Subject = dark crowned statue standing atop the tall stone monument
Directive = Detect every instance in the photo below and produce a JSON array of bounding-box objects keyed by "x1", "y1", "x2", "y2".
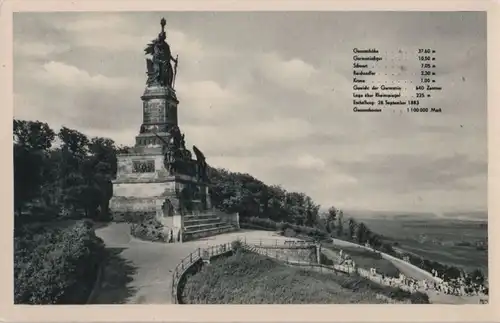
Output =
[{"x1": 144, "y1": 18, "x2": 178, "y2": 88}]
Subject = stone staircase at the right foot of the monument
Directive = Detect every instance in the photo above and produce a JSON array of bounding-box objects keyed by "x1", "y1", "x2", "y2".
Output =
[{"x1": 183, "y1": 212, "x2": 237, "y2": 241}]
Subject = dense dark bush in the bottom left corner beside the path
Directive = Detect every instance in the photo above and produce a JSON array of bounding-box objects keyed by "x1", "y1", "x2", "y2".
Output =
[{"x1": 14, "y1": 221, "x2": 104, "y2": 304}]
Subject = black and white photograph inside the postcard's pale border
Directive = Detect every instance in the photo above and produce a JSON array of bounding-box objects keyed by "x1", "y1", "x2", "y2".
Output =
[{"x1": 10, "y1": 8, "x2": 489, "y2": 308}]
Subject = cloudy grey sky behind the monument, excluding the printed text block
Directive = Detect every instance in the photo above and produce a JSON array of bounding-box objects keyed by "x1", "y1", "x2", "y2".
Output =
[{"x1": 14, "y1": 12, "x2": 487, "y2": 213}]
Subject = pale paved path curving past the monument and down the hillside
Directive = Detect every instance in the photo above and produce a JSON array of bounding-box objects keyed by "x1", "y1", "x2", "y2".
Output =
[{"x1": 91, "y1": 223, "x2": 484, "y2": 304}]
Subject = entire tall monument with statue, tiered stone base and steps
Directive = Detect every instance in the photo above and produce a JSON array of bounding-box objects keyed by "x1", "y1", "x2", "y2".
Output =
[{"x1": 110, "y1": 18, "x2": 239, "y2": 241}]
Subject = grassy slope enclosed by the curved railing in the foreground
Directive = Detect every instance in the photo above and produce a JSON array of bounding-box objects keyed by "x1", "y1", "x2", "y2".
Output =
[{"x1": 182, "y1": 252, "x2": 428, "y2": 304}]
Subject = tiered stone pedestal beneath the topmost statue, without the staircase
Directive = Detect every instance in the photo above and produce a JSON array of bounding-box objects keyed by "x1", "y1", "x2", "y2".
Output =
[{"x1": 110, "y1": 81, "x2": 215, "y2": 240}]
